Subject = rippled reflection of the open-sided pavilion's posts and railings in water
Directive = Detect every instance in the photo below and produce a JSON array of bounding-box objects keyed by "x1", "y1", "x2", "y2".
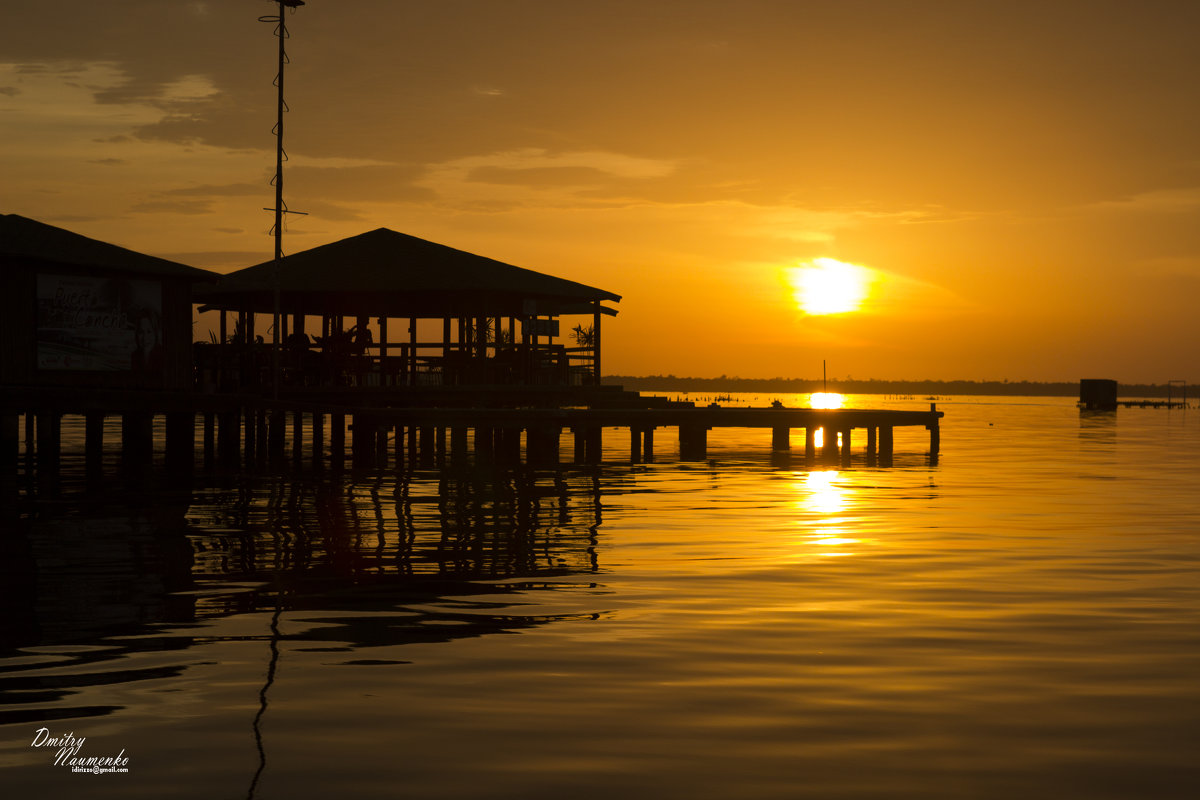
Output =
[{"x1": 183, "y1": 469, "x2": 600, "y2": 612}]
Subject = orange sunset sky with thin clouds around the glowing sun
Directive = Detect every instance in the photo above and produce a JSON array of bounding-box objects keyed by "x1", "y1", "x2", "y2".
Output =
[{"x1": 0, "y1": 0, "x2": 1200, "y2": 383}]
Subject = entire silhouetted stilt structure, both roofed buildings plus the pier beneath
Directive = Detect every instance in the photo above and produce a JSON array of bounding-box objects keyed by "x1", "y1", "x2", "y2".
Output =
[{"x1": 0, "y1": 216, "x2": 942, "y2": 498}]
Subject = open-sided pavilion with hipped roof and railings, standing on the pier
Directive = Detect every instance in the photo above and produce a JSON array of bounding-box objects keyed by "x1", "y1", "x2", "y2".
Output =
[{"x1": 198, "y1": 228, "x2": 620, "y2": 398}]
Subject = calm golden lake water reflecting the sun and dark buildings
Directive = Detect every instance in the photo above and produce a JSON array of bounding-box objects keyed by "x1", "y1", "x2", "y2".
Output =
[{"x1": 0, "y1": 396, "x2": 1200, "y2": 800}]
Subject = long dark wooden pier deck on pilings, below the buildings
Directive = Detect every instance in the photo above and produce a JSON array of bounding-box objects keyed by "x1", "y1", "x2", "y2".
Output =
[{"x1": 0, "y1": 389, "x2": 942, "y2": 494}]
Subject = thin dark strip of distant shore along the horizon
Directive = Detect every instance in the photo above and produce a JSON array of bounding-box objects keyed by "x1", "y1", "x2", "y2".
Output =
[{"x1": 601, "y1": 375, "x2": 1200, "y2": 397}]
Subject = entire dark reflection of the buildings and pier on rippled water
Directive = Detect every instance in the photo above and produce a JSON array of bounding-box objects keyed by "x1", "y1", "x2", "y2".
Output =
[{"x1": 0, "y1": 469, "x2": 601, "y2": 743}]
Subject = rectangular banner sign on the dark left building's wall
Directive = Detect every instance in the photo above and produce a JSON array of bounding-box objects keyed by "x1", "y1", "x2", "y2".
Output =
[{"x1": 37, "y1": 275, "x2": 162, "y2": 372}]
